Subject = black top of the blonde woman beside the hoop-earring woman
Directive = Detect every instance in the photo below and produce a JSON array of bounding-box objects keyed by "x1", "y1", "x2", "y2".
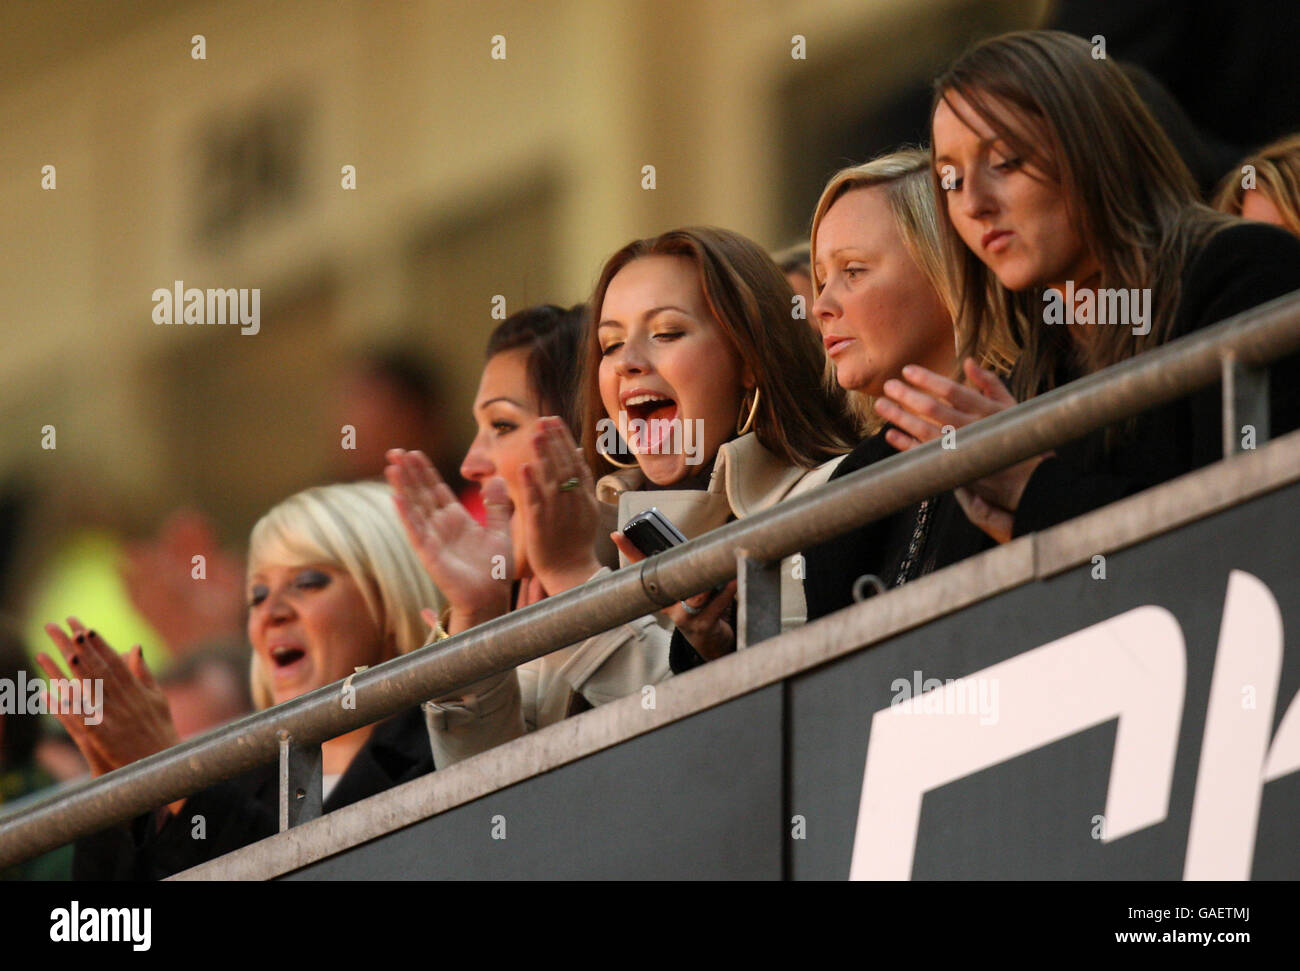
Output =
[{"x1": 803, "y1": 426, "x2": 995, "y2": 620}]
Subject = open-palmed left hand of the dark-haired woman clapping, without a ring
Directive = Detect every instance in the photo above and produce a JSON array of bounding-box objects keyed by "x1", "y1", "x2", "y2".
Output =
[{"x1": 384, "y1": 448, "x2": 514, "y2": 634}]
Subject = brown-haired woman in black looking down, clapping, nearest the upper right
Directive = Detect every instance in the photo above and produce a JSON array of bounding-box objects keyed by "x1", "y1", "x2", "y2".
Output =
[{"x1": 876, "y1": 31, "x2": 1300, "y2": 542}]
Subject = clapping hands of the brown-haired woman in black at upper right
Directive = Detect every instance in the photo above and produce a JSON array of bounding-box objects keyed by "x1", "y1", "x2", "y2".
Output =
[{"x1": 875, "y1": 359, "x2": 1052, "y2": 543}]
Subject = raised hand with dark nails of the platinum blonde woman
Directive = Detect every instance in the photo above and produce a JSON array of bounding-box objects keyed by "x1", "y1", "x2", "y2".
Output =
[{"x1": 36, "y1": 617, "x2": 181, "y2": 776}]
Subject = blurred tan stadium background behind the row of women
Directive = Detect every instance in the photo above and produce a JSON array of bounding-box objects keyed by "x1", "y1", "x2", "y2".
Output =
[{"x1": 0, "y1": 0, "x2": 1300, "y2": 811}]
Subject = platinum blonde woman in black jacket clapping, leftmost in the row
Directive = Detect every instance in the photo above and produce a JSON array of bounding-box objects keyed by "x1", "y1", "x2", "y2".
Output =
[{"x1": 39, "y1": 482, "x2": 442, "y2": 880}]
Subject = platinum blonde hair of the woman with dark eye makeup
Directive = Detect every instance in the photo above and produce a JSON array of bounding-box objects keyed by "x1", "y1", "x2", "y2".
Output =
[{"x1": 248, "y1": 482, "x2": 443, "y2": 708}]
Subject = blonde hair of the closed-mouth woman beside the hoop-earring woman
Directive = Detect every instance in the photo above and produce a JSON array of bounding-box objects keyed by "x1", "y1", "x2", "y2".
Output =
[{"x1": 809, "y1": 148, "x2": 1015, "y2": 434}]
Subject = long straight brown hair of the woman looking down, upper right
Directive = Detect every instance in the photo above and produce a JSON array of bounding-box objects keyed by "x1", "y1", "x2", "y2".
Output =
[{"x1": 930, "y1": 30, "x2": 1231, "y2": 400}]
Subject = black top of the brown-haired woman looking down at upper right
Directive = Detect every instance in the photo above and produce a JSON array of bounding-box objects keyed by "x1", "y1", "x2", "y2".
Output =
[{"x1": 1014, "y1": 222, "x2": 1300, "y2": 536}]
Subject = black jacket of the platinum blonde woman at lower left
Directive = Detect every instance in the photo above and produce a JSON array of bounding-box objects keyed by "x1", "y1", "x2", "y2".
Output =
[{"x1": 73, "y1": 708, "x2": 433, "y2": 880}]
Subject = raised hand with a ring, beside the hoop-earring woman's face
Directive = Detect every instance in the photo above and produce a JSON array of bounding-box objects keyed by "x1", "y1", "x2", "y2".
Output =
[{"x1": 520, "y1": 417, "x2": 601, "y2": 595}]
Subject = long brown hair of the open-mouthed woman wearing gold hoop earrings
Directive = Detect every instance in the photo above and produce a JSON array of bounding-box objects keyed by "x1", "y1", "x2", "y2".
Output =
[{"x1": 581, "y1": 226, "x2": 857, "y2": 474}]
